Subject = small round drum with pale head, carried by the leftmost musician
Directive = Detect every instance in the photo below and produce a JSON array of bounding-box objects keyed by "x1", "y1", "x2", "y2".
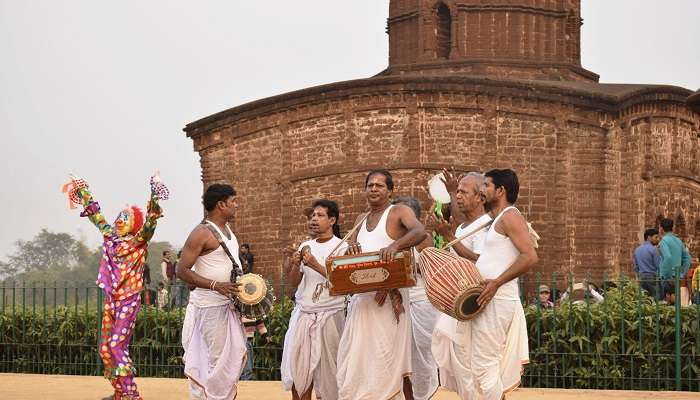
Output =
[{"x1": 233, "y1": 274, "x2": 275, "y2": 320}]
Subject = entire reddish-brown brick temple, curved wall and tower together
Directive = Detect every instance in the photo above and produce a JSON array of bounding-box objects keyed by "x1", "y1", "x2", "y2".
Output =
[{"x1": 185, "y1": 0, "x2": 700, "y2": 288}]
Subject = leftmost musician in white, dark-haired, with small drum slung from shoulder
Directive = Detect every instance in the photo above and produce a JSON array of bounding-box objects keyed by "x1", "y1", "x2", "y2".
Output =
[{"x1": 177, "y1": 184, "x2": 246, "y2": 400}]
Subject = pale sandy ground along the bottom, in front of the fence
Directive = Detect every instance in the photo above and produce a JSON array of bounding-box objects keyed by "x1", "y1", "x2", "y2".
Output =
[{"x1": 0, "y1": 374, "x2": 700, "y2": 400}]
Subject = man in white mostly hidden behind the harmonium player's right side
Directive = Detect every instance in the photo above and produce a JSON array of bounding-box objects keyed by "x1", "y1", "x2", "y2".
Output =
[{"x1": 391, "y1": 196, "x2": 440, "y2": 400}]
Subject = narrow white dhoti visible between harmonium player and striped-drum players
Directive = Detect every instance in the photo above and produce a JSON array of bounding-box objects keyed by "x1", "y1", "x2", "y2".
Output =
[{"x1": 409, "y1": 299, "x2": 438, "y2": 400}]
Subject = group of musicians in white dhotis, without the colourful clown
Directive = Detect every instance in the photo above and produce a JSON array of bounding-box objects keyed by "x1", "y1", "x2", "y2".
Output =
[{"x1": 177, "y1": 170, "x2": 537, "y2": 399}]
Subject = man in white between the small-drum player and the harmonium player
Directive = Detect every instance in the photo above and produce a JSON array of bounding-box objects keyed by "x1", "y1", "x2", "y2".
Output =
[{"x1": 283, "y1": 199, "x2": 346, "y2": 400}]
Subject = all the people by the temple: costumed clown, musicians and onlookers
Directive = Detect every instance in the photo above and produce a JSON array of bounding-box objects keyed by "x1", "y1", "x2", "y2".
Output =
[{"x1": 73, "y1": 169, "x2": 700, "y2": 400}]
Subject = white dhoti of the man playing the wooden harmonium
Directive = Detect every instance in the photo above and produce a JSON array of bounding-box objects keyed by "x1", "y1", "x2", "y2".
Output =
[{"x1": 338, "y1": 290, "x2": 411, "y2": 400}]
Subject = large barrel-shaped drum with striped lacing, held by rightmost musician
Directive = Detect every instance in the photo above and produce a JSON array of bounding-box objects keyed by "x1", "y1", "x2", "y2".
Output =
[{"x1": 418, "y1": 247, "x2": 485, "y2": 321}]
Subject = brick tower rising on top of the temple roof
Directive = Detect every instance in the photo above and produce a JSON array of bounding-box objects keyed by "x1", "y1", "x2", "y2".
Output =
[{"x1": 387, "y1": 0, "x2": 598, "y2": 81}]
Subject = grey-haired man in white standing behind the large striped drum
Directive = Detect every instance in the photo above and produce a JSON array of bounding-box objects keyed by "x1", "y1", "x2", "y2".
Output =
[{"x1": 432, "y1": 172, "x2": 491, "y2": 398}]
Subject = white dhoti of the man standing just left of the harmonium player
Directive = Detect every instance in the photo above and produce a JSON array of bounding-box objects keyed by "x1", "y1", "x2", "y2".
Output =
[{"x1": 290, "y1": 309, "x2": 345, "y2": 400}]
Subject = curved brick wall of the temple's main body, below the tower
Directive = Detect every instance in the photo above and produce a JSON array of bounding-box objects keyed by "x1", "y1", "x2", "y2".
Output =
[{"x1": 188, "y1": 78, "x2": 700, "y2": 281}]
